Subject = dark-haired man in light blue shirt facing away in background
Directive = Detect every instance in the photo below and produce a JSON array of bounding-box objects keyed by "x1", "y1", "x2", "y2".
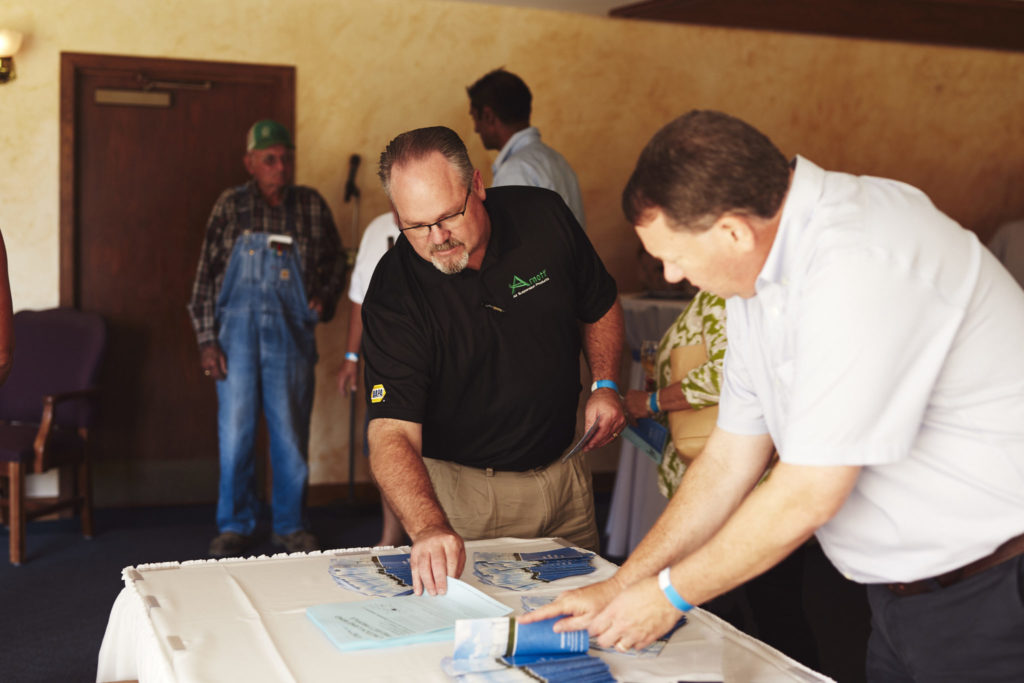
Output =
[{"x1": 466, "y1": 69, "x2": 587, "y2": 229}]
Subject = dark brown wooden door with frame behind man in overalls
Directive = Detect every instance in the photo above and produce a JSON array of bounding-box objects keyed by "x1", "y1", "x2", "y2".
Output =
[{"x1": 60, "y1": 53, "x2": 295, "y2": 505}]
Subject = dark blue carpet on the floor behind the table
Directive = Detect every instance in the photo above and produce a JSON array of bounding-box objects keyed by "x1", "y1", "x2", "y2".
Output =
[{"x1": 0, "y1": 505, "x2": 381, "y2": 683}]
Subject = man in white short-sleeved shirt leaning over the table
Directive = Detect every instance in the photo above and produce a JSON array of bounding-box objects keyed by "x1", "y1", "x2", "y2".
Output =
[{"x1": 522, "y1": 112, "x2": 1024, "y2": 681}]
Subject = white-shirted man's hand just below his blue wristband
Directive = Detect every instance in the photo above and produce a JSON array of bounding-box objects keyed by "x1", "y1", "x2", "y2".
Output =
[{"x1": 588, "y1": 577, "x2": 681, "y2": 652}]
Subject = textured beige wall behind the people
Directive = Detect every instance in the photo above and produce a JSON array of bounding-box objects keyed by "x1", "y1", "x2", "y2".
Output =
[{"x1": 0, "y1": 0, "x2": 1024, "y2": 491}]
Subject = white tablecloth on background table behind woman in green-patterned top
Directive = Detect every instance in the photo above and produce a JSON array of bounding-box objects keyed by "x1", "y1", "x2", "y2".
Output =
[{"x1": 605, "y1": 294, "x2": 689, "y2": 557}]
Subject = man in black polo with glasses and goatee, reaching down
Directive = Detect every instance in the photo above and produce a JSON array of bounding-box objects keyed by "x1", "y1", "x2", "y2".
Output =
[{"x1": 362, "y1": 127, "x2": 626, "y2": 594}]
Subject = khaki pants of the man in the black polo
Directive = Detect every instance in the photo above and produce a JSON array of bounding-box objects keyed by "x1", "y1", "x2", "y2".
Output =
[{"x1": 423, "y1": 454, "x2": 600, "y2": 552}]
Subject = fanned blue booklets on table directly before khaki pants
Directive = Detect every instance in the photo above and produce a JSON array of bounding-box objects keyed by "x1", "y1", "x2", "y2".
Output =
[{"x1": 473, "y1": 548, "x2": 595, "y2": 591}]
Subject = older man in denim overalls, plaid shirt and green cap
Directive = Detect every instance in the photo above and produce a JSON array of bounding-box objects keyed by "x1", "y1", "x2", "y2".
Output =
[{"x1": 188, "y1": 119, "x2": 345, "y2": 557}]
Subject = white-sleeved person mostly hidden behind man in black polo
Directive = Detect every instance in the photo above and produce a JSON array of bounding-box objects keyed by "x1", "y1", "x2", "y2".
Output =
[{"x1": 338, "y1": 211, "x2": 406, "y2": 546}]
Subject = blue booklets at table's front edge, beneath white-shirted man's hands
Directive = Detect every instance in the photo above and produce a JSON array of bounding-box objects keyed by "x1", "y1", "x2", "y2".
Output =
[{"x1": 441, "y1": 616, "x2": 615, "y2": 683}]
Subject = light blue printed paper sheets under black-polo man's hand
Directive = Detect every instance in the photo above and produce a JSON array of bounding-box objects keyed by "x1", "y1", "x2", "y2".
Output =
[{"x1": 306, "y1": 577, "x2": 512, "y2": 652}]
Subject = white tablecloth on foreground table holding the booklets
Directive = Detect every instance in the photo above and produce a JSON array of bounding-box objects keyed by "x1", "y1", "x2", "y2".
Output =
[{"x1": 96, "y1": 539, "x2": 830, "y2": 683}]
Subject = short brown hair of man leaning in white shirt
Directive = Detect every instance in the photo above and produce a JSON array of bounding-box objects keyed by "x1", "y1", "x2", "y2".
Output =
[{"x1": 623, "y1": 111, "x2": 790, "y2": 231}]
